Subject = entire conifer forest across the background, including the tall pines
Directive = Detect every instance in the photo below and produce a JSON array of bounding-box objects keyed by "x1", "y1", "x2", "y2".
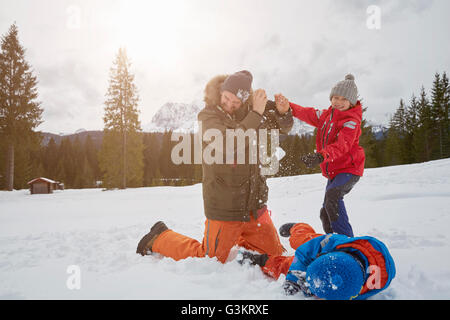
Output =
[{"x1": 0, "y1": 24, "x2": 450, "y2": 190}]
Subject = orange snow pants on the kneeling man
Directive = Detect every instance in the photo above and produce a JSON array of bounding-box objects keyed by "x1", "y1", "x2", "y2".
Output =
[{"x1": 152, "y1": 209, "x2": 285, "y2": 263}]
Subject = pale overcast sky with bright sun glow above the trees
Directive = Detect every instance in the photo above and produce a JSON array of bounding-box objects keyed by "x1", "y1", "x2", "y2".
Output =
[{"x1": 0, "y1": 0, "x2": 450, "y2": 133}]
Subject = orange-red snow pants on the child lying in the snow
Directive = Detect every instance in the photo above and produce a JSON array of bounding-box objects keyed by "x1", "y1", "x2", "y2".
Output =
[{"x1": 262, "y1": 223, "x2": 323, "y2": 279}]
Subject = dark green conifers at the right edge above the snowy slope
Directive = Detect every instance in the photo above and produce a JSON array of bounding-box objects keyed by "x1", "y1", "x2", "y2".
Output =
[{"x1": 381, "y1": 72, "x2": 450, "y2": 165}]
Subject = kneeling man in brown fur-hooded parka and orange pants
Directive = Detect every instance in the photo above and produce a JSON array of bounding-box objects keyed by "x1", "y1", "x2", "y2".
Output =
[{"x1": 136, "y1": 70, "x2": 293, "y2": 263}]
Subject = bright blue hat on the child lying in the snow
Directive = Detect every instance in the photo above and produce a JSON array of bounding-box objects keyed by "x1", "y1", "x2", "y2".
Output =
[{"x1": 306, "y1": 251, "x2": 365, "y2": 300}]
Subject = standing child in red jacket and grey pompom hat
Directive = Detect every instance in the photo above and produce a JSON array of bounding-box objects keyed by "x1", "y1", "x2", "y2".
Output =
[{"x1": 275, "y1": 74, "x2": 365, "y2": 237}]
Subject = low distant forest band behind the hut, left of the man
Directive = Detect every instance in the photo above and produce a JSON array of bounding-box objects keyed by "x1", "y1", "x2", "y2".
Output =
[{"x1": 1, "y1": 132, "x2": 201, "y2": 189}]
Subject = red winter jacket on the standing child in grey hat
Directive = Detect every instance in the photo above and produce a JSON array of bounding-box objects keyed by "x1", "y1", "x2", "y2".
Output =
[{"x1": 290, "y1": 101, "x2": 366, "y2": 179}]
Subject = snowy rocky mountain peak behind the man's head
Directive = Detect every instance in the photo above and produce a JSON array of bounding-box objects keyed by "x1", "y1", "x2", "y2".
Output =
[{"x1": 142, "y1": 102, "x2": 314, "y2": 135}]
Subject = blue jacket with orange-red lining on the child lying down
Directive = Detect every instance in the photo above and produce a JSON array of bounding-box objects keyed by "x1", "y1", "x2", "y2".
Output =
[{"x1": 286, "y1": 234, "x2": 396, "y2": 300}]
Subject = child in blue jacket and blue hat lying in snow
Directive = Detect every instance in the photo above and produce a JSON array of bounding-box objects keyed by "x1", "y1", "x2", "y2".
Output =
[{"x1": 238, "y1": 223, "x2": 395, "y2": 300}]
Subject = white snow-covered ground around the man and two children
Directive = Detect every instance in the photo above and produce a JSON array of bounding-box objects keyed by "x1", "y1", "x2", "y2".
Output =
[{"x1": 0, "y1": 159, "x2": 450, "y2": 300}]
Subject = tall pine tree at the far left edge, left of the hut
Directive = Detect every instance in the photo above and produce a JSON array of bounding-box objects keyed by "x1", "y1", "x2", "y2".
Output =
[{"x1": 0, "y1": 24, "x2": 43, "y2": 190}]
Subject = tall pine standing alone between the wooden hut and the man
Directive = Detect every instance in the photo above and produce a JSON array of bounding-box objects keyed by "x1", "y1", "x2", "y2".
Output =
[{"x1": 99, "y1": 48, "x2": 143, "y2": 189}]
